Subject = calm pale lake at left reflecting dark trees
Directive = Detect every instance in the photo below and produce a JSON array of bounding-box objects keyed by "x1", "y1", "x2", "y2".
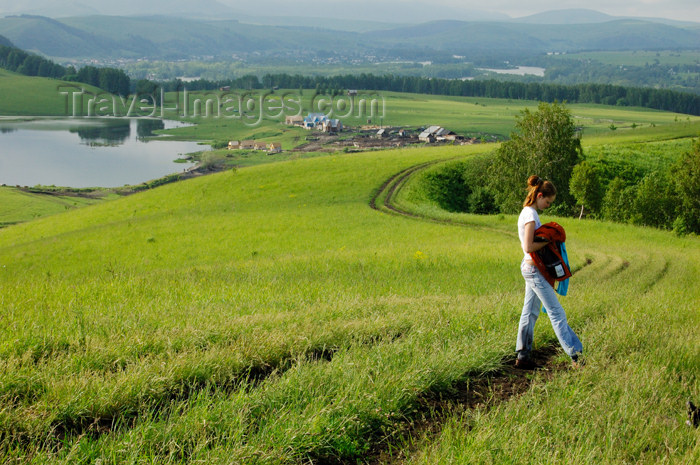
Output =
[{"x1": 0, "y1": 118, "x2": 209, "y2": 187}]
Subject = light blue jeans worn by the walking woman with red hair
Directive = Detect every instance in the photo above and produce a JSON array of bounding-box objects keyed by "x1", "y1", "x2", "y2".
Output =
[{"x1": 515, "y1": 260, "x2": 583, "y2": 359}]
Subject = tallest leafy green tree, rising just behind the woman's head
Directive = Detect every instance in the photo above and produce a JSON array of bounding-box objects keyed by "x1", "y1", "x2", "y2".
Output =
[{"x1": 489, "y1": 102, "x2": 582, "y2": 213}]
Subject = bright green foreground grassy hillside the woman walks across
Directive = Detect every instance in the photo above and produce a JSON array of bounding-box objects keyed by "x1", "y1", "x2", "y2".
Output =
[{"x1": 0, "y1": 140, "x2": 700, "y2": 464}]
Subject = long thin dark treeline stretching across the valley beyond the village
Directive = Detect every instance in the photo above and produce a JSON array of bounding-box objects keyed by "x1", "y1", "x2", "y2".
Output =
[{"x1": 162, "y1": 73, "x2": 700, "y2": 116}]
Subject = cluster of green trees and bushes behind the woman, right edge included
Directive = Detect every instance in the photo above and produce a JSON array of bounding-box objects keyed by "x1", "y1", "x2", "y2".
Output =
[{"x1": 419, "y1": 103, "x2": 700, "y2": 235}]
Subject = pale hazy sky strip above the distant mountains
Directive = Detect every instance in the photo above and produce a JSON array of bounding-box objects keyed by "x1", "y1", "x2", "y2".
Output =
[{"x1": 0, "y1": 0, "x2": 700, "y2": 23}]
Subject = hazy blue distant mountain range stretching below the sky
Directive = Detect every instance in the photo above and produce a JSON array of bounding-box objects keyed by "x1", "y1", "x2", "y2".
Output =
[{"x1": 0, "y1": 11, "x2": 700, "y2": 59}]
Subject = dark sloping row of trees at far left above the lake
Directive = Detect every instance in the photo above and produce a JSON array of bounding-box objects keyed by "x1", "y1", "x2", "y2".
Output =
[{"x1": 0, "y1": 45, "x2": 131, "y2": 96}]
